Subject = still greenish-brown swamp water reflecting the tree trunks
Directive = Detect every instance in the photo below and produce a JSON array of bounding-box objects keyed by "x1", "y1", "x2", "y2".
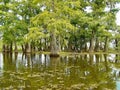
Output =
[{"x1": 0, "y1": 53, "x2": 120, "y2": 90}]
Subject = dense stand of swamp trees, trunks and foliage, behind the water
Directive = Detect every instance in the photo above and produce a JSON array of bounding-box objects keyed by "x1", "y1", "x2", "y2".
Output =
[{"x1": 0, "y1": 0, "x2": 120, "y2": 55}]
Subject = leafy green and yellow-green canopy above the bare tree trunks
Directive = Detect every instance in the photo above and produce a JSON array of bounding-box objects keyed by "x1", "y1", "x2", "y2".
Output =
[{"x1": 0, "y1": 0, "x2": 120, "y2": 52}]
